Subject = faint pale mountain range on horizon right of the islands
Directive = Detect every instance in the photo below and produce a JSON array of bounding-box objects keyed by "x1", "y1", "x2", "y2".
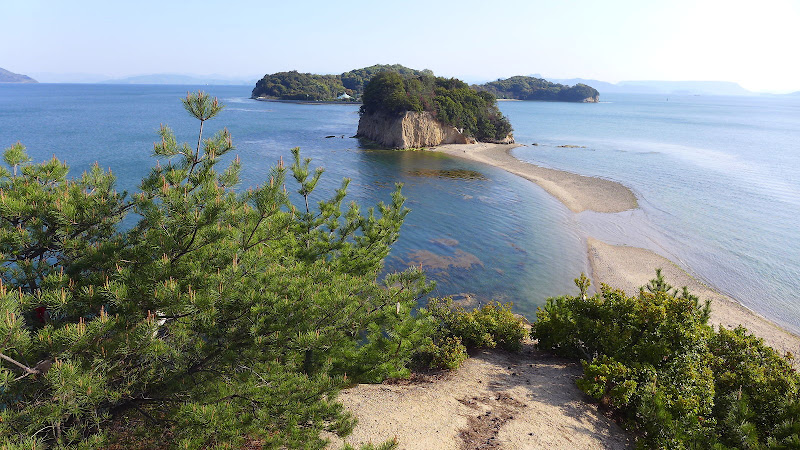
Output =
[{"x1": 548, "y1": 78, "x2": 757, "y2": 95}]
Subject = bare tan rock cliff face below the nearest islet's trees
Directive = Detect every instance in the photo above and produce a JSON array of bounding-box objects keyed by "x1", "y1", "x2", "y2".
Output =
[{"x1": 356, "y1": 111, "x2": 474, "y2": 148}]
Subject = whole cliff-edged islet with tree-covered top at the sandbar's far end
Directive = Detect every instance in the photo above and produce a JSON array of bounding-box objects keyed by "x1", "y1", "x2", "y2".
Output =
[{"x1": 356, "y1": 71, "x2": 514, "y2": 148}]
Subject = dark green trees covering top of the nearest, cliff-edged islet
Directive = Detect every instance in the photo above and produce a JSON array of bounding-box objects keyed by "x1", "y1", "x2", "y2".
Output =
[{"x1": 361, "y1": 72, "x2": 511, "y2": 142}]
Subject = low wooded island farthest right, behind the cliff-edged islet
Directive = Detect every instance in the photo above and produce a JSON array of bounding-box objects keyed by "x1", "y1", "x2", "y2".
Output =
[{"x1": 473, "y1": 76, "x2": 600, "y2": 102}]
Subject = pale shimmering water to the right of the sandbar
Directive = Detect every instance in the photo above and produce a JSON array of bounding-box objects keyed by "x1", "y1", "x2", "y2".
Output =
[{"x1": 501, "y1": 94, "x2": 800, "y2": 331}]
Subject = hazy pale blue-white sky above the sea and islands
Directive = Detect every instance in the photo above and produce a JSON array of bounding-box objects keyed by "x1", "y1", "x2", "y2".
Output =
[{"x1": 0, "y1": 0, "x2": 800, "y2": 91}]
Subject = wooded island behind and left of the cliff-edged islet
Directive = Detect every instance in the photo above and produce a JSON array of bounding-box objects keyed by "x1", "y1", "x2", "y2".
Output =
[{"x1": 252, "y1": 64, "x2": 433, "y2": 101}]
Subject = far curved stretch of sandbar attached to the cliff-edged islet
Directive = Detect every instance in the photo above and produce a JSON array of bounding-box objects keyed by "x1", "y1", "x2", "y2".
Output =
[{"x1": 432, "y1": 143, "x2": 637, "y2": 213}]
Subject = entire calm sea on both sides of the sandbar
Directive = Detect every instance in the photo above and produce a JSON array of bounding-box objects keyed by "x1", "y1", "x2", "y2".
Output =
[{"x1": 0, "y1": 84, "x2": 800, "y2": 331}]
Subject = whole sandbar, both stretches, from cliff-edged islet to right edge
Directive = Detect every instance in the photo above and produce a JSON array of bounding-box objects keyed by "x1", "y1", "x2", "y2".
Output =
[{"x1": 430, "y1": 143, "x2": 800, "y2": 360}]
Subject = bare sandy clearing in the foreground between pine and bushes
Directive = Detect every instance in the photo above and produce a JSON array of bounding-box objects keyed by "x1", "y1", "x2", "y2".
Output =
[{"x1": 332, "y1": 343, "x2": 631, "y2": 450}]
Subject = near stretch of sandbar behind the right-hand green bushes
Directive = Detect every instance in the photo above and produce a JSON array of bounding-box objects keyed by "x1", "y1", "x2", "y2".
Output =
[{"x1": 587, "y1": 238, "x2": 800, "y2": 369}]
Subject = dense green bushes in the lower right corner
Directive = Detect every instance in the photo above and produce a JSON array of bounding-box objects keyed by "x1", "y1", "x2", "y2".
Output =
[{"x1": 532, "y1": 273, "x2": 800, "y2": 449}]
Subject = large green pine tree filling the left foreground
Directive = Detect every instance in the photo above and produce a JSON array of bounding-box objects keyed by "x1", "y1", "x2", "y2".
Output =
[{"x1": 0, "y1": 93, "x2": 431, "y2": 448}]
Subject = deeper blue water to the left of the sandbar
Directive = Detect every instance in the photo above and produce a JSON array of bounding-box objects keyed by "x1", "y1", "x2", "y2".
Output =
[{"x1": 0, "y1": 84, "x2": 588, "y2": 315}]
